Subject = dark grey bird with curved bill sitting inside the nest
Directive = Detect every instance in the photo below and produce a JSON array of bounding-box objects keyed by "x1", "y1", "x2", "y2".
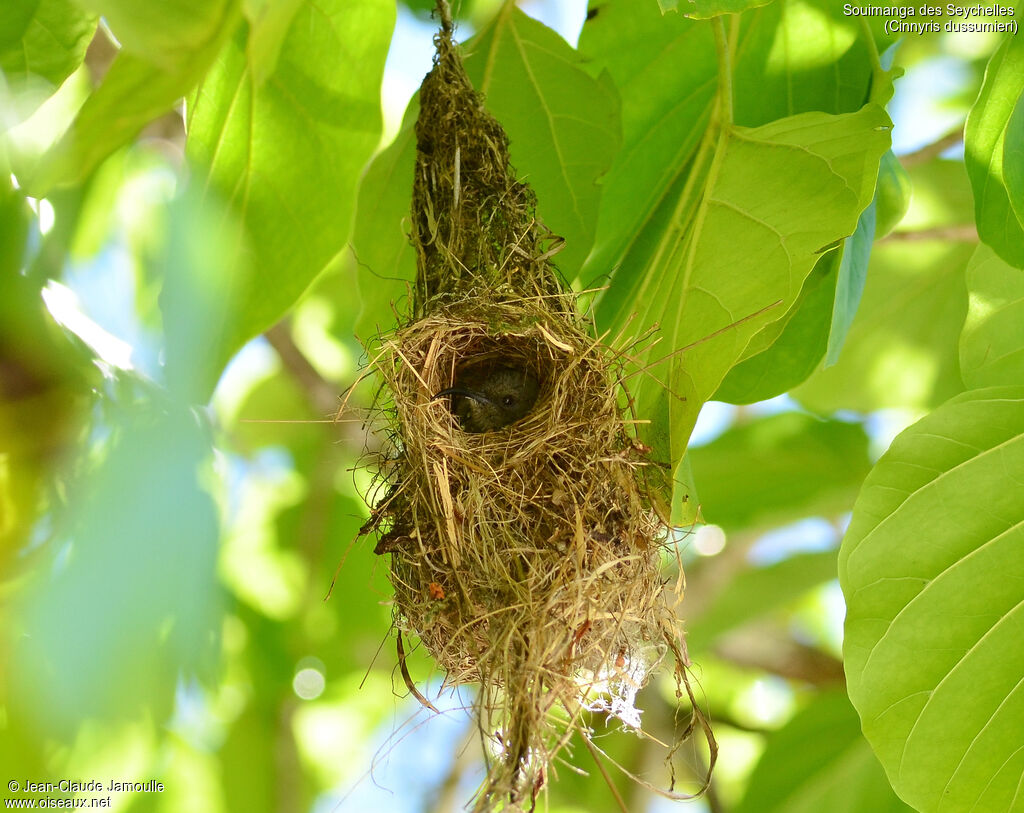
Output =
[{"x1": 433, "y1": 366, "x2": 541, "y2": 433}]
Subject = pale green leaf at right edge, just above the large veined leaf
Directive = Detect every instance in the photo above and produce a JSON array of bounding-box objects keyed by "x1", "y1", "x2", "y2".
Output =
[{"x1": 959, "y1": 245, "x2": 1024, "y2": 387}]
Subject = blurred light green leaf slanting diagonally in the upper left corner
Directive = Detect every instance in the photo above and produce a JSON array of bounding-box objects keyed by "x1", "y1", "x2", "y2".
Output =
[{"x1": 27, "y1": 0, "x2": 236, "y2": 197}]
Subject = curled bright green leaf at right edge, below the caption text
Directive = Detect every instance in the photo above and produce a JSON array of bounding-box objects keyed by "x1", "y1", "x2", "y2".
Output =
[{"x1": 964, "y1": 36, "x2": 1024, "y2": 268}]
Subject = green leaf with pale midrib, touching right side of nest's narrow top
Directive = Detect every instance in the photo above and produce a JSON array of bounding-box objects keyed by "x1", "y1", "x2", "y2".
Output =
[{"x1": 466, "y1": 3, "x2": 622, "y2": 279}]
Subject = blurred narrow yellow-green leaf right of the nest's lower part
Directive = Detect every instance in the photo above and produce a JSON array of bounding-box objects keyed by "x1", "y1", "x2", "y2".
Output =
[{"x1": 686, "y1": 551, "x2": 836, "y2": 652}]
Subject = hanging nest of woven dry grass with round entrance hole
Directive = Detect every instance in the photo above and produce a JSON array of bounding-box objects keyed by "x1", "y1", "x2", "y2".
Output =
[{"x1": 365, "y1": 0, "x2": 712, "y2": 811}]
